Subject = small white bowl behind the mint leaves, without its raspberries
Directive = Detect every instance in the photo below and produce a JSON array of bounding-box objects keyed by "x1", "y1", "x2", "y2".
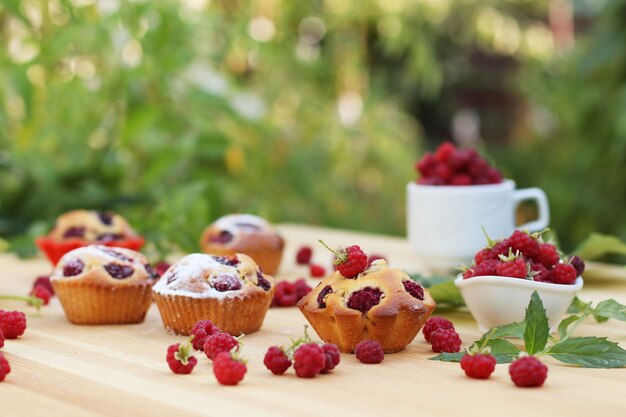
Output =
[{"x1": 454, "y1": 274, "x2": 583, "y2": 333}]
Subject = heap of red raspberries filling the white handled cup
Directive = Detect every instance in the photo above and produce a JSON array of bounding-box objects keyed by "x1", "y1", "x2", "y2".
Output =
[{"x1": 415, "y1": 142, "x2": 502, "y2": 185}]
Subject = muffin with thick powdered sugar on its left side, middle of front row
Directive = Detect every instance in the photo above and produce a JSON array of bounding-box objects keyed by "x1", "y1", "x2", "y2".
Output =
[{"x1": 153, "y1": 253, "x2": 274, "y2": 336}]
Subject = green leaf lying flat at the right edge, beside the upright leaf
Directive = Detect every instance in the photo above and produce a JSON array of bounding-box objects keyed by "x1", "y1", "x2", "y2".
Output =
[{"x1": 547, "y1": 337, "x2": 626, "y2": 368}]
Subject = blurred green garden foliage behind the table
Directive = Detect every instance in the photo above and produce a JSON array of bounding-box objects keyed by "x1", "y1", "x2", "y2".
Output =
[{"x1": 0, "y1": 0, "x2": 626, "y2": 253}]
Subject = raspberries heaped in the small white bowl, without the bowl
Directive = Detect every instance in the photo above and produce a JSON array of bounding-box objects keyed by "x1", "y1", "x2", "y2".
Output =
[{"x1": 463, "y1": 230, "x2": 585, "y2": 284}]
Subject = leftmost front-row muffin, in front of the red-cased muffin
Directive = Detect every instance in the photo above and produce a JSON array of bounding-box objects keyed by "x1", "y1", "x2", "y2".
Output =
[{"x1": 50, "y1": 245, "x2": 155, "y2": 324}]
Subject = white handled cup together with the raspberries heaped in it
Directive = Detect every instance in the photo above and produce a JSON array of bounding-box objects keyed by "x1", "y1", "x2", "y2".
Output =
[{"x1": 407, "y1": 142, "x2": 550, "y2": 271}]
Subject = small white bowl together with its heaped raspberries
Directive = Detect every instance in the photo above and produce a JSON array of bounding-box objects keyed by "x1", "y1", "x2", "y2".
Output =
[{"x1": 454, "y1": 230, "x2": 585, "y2": 332}]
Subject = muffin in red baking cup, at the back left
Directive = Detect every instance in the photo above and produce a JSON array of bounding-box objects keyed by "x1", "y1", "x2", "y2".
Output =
[{"x1": 37, "y1": 210, "x2": 144, "y2": 264}]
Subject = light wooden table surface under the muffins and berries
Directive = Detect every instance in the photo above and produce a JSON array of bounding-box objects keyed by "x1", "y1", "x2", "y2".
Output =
[{"x1": 0, "y1": 225, "x2": 626, "y2": 417}]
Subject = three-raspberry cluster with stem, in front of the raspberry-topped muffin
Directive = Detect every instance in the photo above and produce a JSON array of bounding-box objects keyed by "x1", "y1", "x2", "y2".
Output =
[{"x1": 263, "y1": 326, "x2": 341, "y2": 378}]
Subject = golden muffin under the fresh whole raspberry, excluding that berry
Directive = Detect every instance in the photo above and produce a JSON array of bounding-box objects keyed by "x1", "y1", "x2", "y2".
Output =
[{"x1": 298, "y1": 259, "x2": 435, "y2": 353}]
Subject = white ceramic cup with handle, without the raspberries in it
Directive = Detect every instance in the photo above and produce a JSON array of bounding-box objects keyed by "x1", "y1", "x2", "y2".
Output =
[{"x1": 407, "y1": 180, "x2": 550, "y2": 271}]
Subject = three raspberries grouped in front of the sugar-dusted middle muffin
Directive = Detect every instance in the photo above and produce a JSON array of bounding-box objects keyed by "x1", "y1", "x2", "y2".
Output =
[{"x1": 166, "y1": 320, "x2": 247, "y2": 385}]
